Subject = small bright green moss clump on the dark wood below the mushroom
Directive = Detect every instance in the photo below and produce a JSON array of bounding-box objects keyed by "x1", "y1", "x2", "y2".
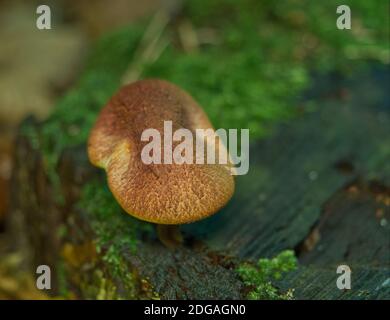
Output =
[{"x1": 236, "y1": 250, "x2": 297, "y2": 300}]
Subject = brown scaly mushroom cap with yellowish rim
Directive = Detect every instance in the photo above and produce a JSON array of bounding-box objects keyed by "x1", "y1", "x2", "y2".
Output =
[{"x1": 88, "y1": 80, "x2": 234, "y2": 224}]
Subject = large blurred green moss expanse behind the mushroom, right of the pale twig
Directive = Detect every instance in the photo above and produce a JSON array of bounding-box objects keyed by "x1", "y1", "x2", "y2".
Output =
[{"x1": 144, "y1": 0, "x2": 389, "y2": 137}]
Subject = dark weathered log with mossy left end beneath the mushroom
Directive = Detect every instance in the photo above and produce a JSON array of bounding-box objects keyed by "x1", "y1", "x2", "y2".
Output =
[{"x1": 9, "y1": 63, "x2": 390, "y2": 299}]
